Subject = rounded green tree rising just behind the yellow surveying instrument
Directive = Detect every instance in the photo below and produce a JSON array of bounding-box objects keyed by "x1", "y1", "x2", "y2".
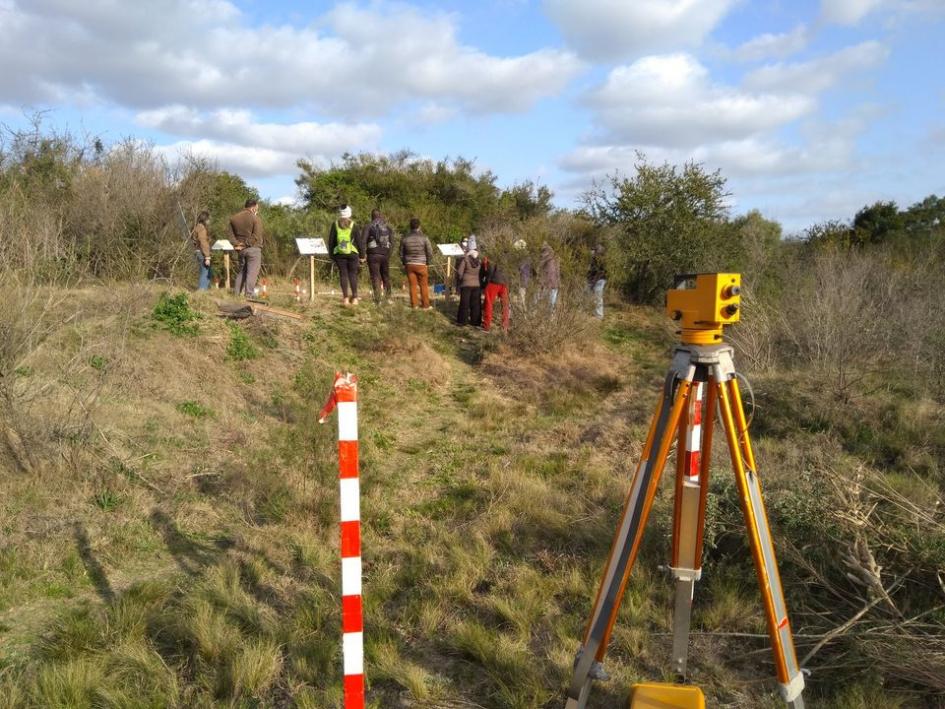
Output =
[{"x1": 583, "y1": 153, "x2": 735, "y2": 303}]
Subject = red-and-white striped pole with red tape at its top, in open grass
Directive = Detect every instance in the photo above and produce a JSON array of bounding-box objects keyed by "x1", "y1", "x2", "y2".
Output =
[{"x1": 318, "y1": 372, "x2": 364, "y2": 709}]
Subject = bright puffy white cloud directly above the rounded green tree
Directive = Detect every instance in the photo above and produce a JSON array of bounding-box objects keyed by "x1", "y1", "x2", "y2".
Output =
[{"x1": 590, "y1": 54, "x2": 814, "y2": 147}]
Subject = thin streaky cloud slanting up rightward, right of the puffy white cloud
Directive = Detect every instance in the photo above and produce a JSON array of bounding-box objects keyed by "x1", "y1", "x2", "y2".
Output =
[{"x1": 744, "y1": 41, "x2": 889, "y2": 93}]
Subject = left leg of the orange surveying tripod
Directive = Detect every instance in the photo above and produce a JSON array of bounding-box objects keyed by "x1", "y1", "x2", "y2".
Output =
[{"x1": 565, "y1": 356, "x2": 695, "y2": 709}]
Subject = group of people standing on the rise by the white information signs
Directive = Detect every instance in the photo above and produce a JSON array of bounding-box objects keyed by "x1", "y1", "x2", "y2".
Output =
[{"x1": 191, "y1": 199, "x2": 607, "y2": 320}]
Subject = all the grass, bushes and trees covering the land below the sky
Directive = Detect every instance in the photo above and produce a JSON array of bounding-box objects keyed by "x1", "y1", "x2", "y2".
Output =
[{"x1": 0, "y1": 123, "x2": 945, "y2": 709}]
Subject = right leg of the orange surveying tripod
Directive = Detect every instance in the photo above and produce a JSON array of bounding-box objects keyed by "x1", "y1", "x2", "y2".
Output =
[{"x1": 713, "y1": 374, "x2": 804, "y2": 709}]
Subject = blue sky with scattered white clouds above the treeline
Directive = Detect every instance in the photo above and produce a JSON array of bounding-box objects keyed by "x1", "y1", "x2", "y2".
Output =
[{"x1": 0, "y1": 0, "x2": 945, "y2": 234}]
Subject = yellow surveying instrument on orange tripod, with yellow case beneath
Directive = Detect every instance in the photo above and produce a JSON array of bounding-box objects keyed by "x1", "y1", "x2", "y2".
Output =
[{"x1": 565, "y1": 273, "x2": 804, "y2": 709}]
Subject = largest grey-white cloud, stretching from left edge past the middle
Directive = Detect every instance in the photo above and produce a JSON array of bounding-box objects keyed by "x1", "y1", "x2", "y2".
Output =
[{"x1": 0, "y1": 0, "x2": 583, "y2": 117}]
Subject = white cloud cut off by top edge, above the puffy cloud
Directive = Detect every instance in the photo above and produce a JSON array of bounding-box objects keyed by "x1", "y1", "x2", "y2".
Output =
[{"x1": 544, "y1": 0, "x2": 737, "y2": 60}]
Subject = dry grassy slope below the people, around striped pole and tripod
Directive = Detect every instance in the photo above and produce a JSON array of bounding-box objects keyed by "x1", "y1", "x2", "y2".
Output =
[{"x1": 0, "y1": 286, "x2": 945, "y2": 708}]
